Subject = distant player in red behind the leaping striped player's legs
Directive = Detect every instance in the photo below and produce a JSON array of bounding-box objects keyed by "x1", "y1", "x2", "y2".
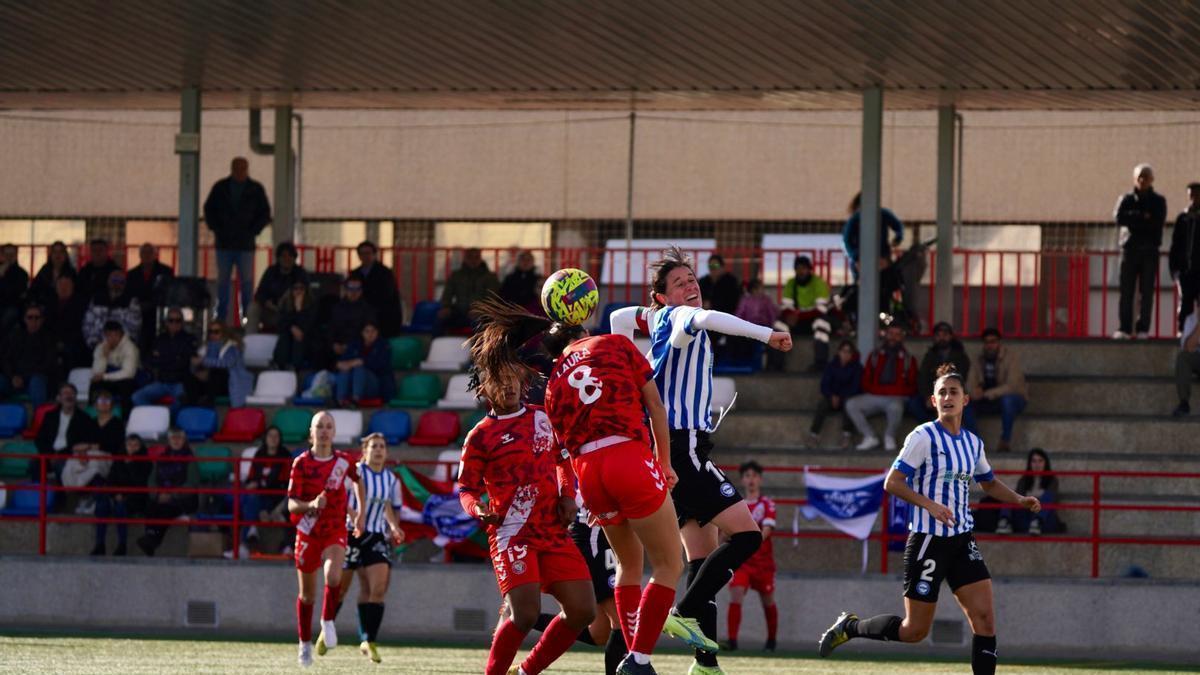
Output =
[{"x1": 725, "y1": 460, "x2": 779, "y2": 651}]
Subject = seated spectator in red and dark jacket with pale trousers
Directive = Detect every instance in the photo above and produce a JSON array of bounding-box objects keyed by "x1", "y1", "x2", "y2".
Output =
[{"x1": 846, "y1": 323, "x2": 917, "y2": 452}]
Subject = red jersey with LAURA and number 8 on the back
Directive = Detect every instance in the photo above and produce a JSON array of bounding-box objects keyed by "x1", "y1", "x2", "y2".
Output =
[{"x1": 546, "y1": 335, "x2": 654, "y2": 456}]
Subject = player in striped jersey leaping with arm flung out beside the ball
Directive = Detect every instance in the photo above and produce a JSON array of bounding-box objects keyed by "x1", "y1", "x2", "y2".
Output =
[{"x1": 612, "y1": 246, "x2": 792, "y2": 675}]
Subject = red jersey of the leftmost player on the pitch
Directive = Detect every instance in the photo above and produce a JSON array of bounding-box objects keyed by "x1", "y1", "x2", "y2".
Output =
[{"x1": 288, "y1": 450, "x2": 359, "y2": 537}]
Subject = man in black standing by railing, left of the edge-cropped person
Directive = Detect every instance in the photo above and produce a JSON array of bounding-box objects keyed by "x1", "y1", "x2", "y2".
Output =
[{"x1": 1112, "y1": 165, "x2": 1166, "y2": 340}]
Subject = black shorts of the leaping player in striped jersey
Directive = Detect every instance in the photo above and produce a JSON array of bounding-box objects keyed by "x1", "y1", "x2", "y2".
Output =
[{"x1": 671, "y1": 429, "x2": 742, "y2": 527}]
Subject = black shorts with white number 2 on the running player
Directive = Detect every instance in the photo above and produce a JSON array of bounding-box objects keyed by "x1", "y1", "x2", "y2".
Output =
[{"x1": 904, "y1": 532, "x2": 991, "y2": 603}]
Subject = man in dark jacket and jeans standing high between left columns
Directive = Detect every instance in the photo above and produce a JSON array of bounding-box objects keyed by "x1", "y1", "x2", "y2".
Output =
[{"x1": 204, "y1": 157, "x2": 271, "y2": 321}]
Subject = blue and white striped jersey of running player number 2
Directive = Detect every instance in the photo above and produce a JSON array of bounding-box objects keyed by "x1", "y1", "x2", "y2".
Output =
[{"x1": 892, "y1": 422, "x2": 995, "y2": 537}]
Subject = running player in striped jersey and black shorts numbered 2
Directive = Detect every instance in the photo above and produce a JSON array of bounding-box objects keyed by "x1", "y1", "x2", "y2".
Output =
[{"x1": 820, "y1": 364, "x2": 1042, "y2": 675}]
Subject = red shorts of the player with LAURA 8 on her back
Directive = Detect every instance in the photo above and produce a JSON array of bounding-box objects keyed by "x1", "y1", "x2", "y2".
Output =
[{"x1": 574, "y1": 441, "x2": 667, "y2": 525}]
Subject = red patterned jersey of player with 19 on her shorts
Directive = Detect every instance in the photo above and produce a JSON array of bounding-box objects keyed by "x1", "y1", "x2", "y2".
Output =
[{"x1": 458, "y1": 406, "x2": 575, "y2": 556}]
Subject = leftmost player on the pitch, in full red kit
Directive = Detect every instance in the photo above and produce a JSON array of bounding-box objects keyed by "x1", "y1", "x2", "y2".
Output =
[{"x1": 288, "y1": 411, "x2": 365, "y2": 667}]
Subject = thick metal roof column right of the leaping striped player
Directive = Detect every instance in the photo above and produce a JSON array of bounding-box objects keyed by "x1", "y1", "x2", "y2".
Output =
[{"x1": 858, "y1": 86, "x2": 883, "y2": 358}]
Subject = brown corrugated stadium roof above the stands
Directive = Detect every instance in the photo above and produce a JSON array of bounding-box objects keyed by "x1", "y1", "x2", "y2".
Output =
[{"x1": 0, "y1": 0, "x2": 1200, "y2": 109}]
